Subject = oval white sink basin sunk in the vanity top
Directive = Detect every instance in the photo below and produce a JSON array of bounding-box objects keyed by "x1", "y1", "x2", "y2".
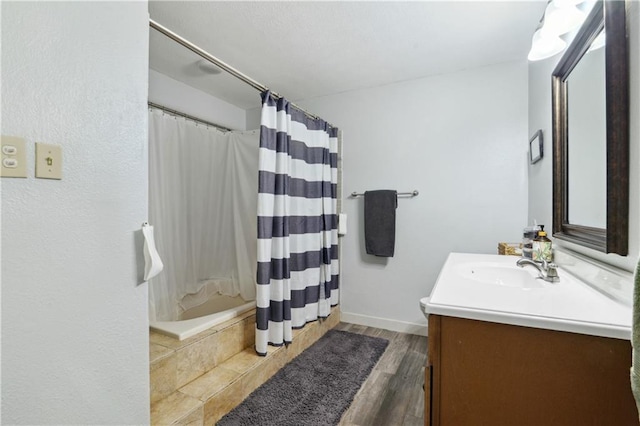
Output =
[{"x1": 456, "y1": 262, "x2": 544, "y2": 289}]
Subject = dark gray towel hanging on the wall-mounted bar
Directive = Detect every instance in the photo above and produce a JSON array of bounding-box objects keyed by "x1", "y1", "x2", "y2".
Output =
[{"x1": 364, "y1": 190, "x2": 398, "y2": 257}]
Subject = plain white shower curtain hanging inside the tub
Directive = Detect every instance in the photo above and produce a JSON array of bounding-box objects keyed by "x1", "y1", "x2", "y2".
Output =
[{"x1": 149, "y1": 109, "x2": 258, "y2": 321}]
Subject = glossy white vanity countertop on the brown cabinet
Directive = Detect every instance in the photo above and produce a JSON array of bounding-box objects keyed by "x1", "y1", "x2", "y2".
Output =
[{"x1": 427, "y1": 253, "x2": 632, "y2": 340}]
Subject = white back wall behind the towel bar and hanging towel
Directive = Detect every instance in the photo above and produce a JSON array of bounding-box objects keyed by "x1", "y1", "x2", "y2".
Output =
[{"x1": 296, "y1": 61, "x2": 528, "y2": 332}]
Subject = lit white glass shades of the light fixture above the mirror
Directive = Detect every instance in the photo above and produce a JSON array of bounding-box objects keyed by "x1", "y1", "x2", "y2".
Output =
[{"x1": 527, "y1": 0, "x2": 586, "y2": 61}]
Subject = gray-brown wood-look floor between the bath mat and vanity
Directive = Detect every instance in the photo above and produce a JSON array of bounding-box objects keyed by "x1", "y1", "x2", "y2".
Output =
[{"x1": 335, "y1": 323, "x2": 427, "y2": 426}]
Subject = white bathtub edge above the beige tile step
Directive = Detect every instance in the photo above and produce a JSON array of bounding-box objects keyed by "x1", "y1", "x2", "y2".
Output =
[{"x1": 149, "y1": 301, "x2": 256, "y2": 340}]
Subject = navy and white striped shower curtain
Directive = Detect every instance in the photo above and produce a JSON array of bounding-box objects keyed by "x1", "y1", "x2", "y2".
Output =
[{"x1": 256, "y1": 91, "x2": 339, "y2": 355}]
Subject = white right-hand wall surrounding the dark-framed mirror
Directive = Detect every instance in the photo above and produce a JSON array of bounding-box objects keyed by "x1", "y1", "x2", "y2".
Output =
[{"x1": 528, "y1": 1, "x2": 640, "y2": 271}]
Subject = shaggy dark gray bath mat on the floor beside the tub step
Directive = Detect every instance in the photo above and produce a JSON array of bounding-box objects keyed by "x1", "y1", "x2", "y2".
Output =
[{"x1": 217, "y1": 330, "x2": 389, "y2": 426}]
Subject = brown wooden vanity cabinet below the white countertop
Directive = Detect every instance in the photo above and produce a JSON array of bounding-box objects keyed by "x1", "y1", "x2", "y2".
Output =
[{"x1": 425, "y1": 315, "x2": 639, "y2": 426}]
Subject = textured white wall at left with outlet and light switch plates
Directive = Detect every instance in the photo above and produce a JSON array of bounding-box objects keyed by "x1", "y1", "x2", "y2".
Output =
[{"x1": 1, "y1": 2, "x2": 149, "y2": 424}]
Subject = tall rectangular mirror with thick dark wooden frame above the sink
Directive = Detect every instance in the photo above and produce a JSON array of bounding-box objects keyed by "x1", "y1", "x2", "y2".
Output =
[{"x1": 552, "y1": 0, "x2": 629, "y2": 256}]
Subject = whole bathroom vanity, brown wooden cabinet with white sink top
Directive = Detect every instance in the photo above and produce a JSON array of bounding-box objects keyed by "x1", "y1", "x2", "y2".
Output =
[{"x1": 425, "y1": 253, "x2": 638, "y2": 426}]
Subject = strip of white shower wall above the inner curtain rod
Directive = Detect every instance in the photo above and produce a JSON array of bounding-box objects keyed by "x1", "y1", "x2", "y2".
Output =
[{"x1": 149, "y1": 69, "x2": 248, "y2": 130}]
